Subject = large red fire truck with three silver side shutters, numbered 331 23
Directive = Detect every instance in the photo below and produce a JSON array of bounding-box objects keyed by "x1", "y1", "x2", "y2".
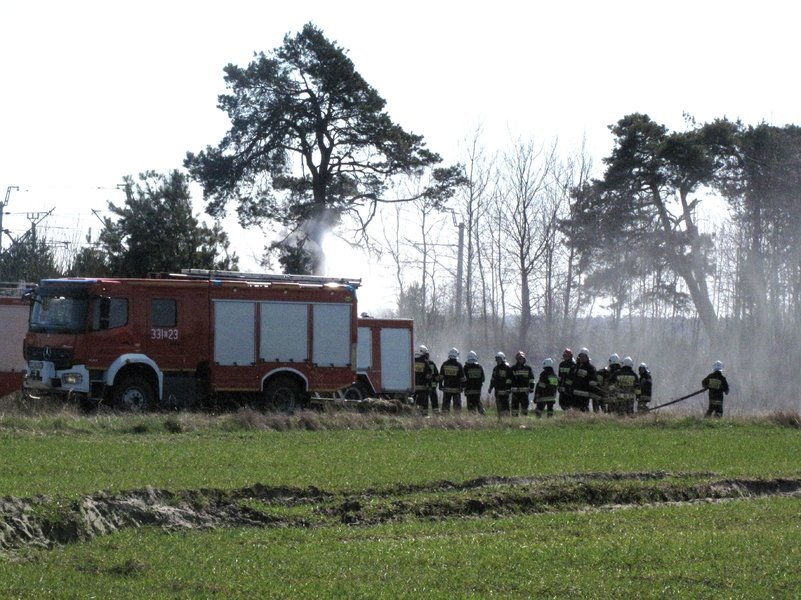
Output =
[{"x1": 24, "y1": 270, "x2": 360, "y2": 410}]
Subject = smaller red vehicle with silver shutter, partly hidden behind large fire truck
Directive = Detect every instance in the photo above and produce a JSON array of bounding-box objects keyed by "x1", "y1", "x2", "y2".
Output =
[{"x1": 348, "y1": 317, "x2": 414, "y2": 399}]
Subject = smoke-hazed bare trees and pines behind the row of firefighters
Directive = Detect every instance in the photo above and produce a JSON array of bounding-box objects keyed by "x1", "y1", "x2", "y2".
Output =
[{"x1": 382, "y1": 114, "x2": 801, "y2": 409}]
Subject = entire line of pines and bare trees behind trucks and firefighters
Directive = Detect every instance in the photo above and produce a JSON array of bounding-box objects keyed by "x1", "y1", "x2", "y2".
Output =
[{"x1": 0, "y1": 23, "x2": 801, "y2": 409}]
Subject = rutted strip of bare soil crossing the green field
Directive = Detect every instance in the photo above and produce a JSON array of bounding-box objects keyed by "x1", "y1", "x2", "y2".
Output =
[{"x1": 0, "y1": 471, "x2": 801, "y2": 552}]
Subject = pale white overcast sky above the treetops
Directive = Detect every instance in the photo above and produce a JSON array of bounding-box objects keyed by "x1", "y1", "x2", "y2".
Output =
[{"x1": 0, "y1": 0, "x2": 801, "y2": 308}]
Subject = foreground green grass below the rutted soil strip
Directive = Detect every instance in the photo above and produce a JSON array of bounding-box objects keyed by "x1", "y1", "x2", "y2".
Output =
[{"x1": 6, "y1": 498, "x2": 801, "y2": 599}]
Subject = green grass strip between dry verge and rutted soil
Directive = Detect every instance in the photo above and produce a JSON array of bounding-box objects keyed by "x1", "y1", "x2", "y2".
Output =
[{"x1": 0, "y1": 417, "x2": 801, "y2": 497}]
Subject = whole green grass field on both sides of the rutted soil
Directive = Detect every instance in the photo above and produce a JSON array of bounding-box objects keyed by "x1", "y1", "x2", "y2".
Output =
[{"x1": 0, "y1": 415, "x2": 801, "y2": 598}]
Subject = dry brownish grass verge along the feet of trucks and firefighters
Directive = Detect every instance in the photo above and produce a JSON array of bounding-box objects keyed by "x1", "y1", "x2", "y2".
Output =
[{"x1": 0, "y1": 396, "x2": 801, "y2": 434}]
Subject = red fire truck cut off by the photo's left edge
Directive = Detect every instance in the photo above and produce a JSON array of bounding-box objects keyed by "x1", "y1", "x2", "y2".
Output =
[{"x1": 0, "y1": 288, "x2": 29, "y2": 398}]
